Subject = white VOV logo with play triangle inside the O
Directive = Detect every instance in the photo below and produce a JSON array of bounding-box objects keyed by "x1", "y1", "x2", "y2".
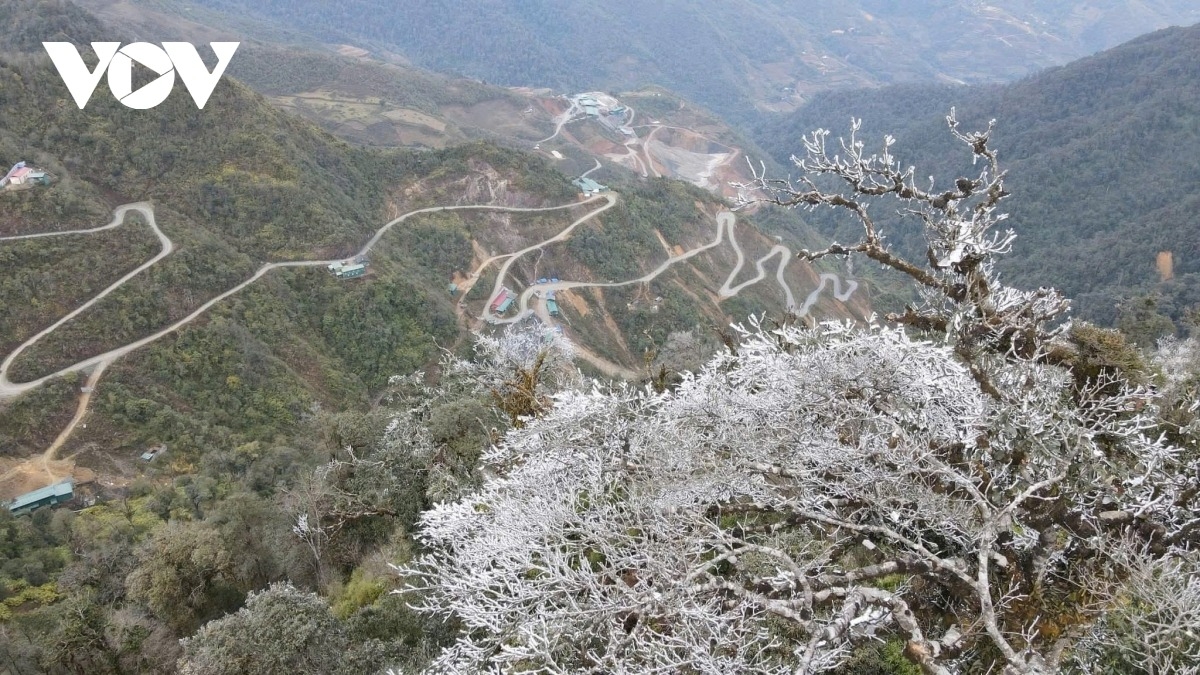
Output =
[{"x1": 42, "y1": 42, "x2": 241, "y2": 110}]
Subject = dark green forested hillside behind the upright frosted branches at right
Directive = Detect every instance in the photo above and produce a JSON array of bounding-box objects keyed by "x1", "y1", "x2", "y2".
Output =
[{"x1": 757, "y1": 26, "x2": 1200, "y2": 331}]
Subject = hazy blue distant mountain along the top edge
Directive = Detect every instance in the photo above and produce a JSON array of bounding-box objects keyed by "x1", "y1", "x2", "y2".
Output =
[{"x1": 180, "y1": 0, "x2": 1200, "y2": 114}]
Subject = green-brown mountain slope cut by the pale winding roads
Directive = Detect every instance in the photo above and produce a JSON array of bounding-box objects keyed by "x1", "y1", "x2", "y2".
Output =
[{"x1": 0, "y1": 1, "x2": 865, "y2": 487}]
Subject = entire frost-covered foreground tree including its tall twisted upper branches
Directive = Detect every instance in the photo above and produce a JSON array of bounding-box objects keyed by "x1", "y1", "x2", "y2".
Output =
[{"x1": 402, "y1": 114, "x2": 1200, "y2": 674}]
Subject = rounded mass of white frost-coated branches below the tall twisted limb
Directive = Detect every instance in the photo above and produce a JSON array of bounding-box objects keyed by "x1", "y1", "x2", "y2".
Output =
[{"x1": 405, "y1": 314, "x2": 1177, "y2": 674}]
